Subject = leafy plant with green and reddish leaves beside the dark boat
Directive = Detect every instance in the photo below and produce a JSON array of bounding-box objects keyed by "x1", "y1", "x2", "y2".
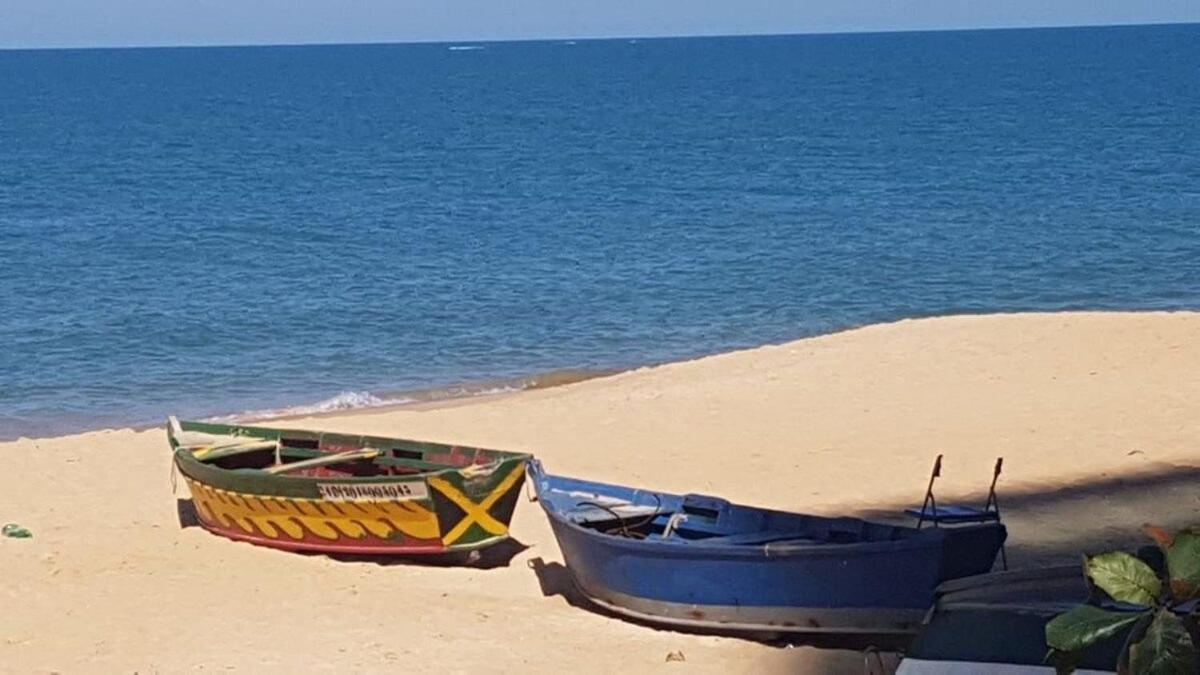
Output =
[{"x1": 1046, "y1": 525, "x2": 1200, "y2": 675}]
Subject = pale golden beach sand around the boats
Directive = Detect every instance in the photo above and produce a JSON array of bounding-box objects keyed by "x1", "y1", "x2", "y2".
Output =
[{"x1": 0, "y1": 312, "x2": 1200, "y2": 673}]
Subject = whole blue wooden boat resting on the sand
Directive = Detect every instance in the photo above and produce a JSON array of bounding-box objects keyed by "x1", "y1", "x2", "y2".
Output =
[{"x1": 529, "y1": 460, "x2": 1006, "y2": 634}]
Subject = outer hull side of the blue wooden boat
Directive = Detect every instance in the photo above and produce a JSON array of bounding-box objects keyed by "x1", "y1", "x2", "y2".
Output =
[{"x1": 535, "y1": 461, "x2": 1004, "y2": 634}]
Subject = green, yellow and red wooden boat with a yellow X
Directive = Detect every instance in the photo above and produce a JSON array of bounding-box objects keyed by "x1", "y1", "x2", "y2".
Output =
[{"x1": 167, "y1": 418, "x2": 529, "y2": 555}]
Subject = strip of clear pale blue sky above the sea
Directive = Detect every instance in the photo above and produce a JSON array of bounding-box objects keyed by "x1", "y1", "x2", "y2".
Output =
[{"x1": 0, "y1": 0, "x2": 1200, "y2": 47}]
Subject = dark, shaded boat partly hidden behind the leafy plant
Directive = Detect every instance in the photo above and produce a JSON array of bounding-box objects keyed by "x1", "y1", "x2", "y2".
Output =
[{"x1": 896, "y1": 565, "x2": 1129, "y2": 675}]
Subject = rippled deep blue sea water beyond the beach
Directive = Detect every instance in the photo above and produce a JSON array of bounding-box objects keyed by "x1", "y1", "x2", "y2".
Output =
[{"x1": 0, "y1": 25, "x2": 1200, "y2": 437}]
